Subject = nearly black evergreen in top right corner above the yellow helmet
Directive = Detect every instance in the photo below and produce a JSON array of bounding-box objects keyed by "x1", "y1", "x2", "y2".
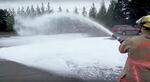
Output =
[{"x1": 126, "y1": 0, "x2": 150, "y2": 24}]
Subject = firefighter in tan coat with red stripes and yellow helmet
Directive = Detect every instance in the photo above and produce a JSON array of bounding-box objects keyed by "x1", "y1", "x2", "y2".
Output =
[{"x1": 119, "y1": 15, "x2": 150, "y2": 82}]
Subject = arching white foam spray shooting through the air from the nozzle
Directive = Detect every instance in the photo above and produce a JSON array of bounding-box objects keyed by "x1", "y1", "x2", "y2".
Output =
[{"x1": 15, "y1": 13, "x2": 112, "y2": 35}]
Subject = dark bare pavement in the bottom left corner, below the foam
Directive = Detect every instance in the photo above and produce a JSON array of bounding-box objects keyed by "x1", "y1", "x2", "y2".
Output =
[{"x1": 0, "y1": 59, "x2": 83, "y2": 82}]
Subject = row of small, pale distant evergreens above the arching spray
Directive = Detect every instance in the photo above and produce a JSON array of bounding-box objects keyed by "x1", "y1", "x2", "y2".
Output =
[{"x1": 8, "y1": 2, "x2": 88, "y2": 17}]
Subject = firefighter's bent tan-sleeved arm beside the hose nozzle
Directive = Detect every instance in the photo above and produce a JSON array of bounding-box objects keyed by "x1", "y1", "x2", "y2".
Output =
[{"x1": 119, "y1": 39, "x2": 130, "y2": 53}]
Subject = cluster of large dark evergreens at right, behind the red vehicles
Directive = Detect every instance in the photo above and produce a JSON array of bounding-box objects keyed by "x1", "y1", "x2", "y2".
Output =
[{"x1": 94, "y1": 0, "x2": 150, "y2": 29}]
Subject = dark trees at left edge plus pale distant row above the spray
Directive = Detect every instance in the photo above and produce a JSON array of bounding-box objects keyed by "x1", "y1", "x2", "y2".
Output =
[{"x1": 0, "y1": 2, "x2": 95, "y2": 32}]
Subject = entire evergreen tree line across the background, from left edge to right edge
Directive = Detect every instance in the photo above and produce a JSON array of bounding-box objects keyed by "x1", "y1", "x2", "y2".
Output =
[{"x1": 0, "y1": 0, "x2": 150, "y2": 31}]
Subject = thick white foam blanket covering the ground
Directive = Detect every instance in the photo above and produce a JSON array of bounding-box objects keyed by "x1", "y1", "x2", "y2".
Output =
[{"x1": 0, "y1": 34, "x2": 126, "y2": 80}]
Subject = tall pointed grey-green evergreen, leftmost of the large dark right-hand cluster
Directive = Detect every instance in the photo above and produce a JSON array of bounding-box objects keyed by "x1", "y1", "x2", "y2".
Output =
[{"x1": 97, "y1": 0, "x2": 107, "y2": 25}]
